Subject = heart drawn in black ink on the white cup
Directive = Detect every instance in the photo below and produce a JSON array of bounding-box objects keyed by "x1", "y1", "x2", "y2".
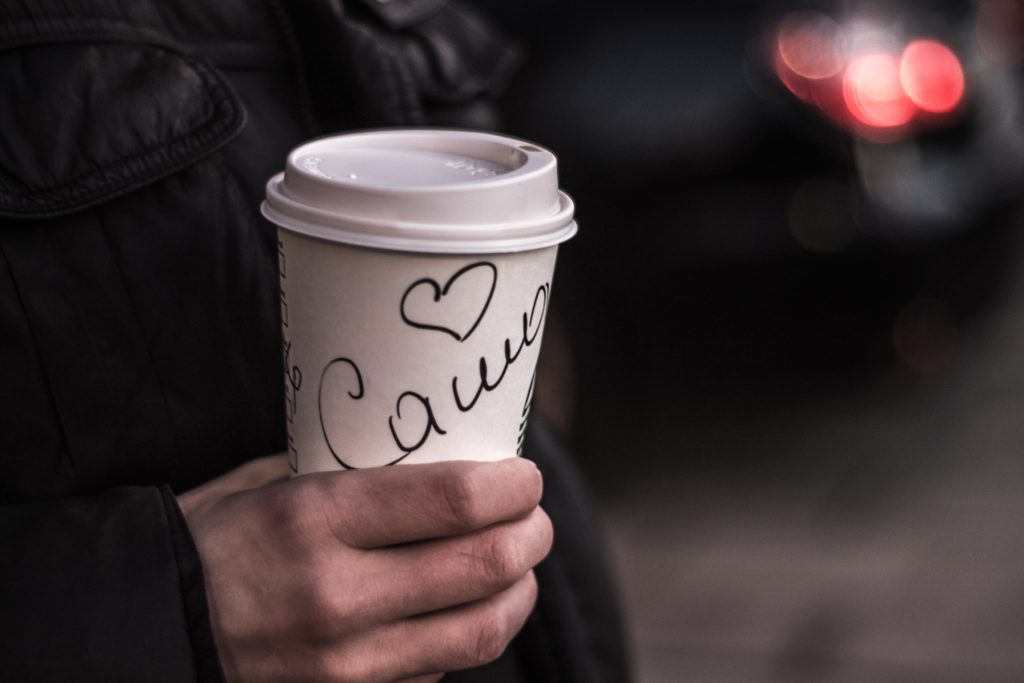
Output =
[{"x1": 400, "y1": 261, "x2": 498, "y2": 342}]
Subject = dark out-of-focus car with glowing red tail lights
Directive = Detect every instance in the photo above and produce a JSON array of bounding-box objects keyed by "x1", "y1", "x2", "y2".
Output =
[{"x1": 478, "y1": 0, "x2": 1024, "y2": 391}]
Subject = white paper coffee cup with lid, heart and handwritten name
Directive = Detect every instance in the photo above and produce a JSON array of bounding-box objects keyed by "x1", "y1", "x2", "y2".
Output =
[{"x1": 262, "y1": 130, "x2": 577, "y2": 473}]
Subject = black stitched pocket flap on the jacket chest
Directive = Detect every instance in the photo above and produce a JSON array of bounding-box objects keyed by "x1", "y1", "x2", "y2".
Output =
[{"x1": 0, "y1": 38, "x2": 245, "y2": 218}]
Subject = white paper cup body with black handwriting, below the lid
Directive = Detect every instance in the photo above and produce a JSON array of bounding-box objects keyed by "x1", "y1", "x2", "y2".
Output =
[{"x1": 279, "y1": 227, "x2": 558, "y2": 474}]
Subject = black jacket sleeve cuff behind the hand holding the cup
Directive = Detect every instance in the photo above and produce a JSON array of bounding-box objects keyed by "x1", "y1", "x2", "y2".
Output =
[{"x1": 0, "y1": 486, "x2": 223, "y2": 683}]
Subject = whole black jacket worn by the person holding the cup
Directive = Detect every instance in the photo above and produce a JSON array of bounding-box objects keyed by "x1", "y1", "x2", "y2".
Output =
[{"x1": 0, "y1": 0, "x2": 626, "y2": 683}]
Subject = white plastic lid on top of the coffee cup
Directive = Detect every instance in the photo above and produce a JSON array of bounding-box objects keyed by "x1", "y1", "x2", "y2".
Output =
[{"x1": 261, "y1": 129, "x2": 577, "y2": 254}]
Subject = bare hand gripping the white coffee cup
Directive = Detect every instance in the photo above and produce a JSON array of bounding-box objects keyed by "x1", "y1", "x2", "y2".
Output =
[{"x1": 179, "y1": 457, "x2": 552, "y2": 683}]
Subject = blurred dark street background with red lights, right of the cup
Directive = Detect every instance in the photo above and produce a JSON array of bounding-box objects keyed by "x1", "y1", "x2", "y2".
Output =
[{"x1": 475, "y1": 0, "x2": 1024, "y2": 683}]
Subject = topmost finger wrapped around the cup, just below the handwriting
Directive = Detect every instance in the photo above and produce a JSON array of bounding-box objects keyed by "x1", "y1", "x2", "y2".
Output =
[{"x1": 314, "y1": 458, "x2": 543, "y2": 548}]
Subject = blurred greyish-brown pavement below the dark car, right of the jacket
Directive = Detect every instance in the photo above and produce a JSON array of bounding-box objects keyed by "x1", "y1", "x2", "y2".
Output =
[{"x1": 574, "y1": 225, "x2": 1024, "y2": 683}]
